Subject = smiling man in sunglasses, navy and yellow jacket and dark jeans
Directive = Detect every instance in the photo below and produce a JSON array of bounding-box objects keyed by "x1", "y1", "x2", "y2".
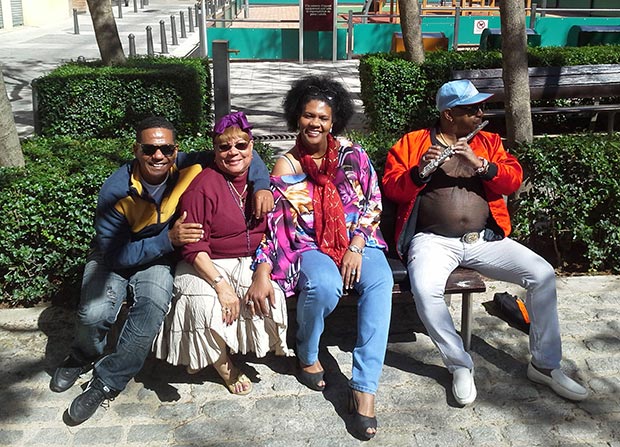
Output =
[{"x1": 50, "y1": 117, "x2": 273, "y2": 423}]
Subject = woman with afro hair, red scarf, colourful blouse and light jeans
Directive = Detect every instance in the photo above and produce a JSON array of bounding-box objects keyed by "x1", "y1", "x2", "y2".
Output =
[{"x1": 254, "y1": 76, "x2": 393, "y2": 439}]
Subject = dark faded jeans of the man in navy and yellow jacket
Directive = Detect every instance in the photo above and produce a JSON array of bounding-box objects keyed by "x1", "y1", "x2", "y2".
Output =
[{"x1": 73, "y1": 253, "x2": 173, "y2": 392}]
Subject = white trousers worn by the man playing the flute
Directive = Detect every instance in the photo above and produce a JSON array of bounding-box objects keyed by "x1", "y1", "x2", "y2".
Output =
[{"x1": 407, "y1": 233, "x2": 562, "y2": 373}]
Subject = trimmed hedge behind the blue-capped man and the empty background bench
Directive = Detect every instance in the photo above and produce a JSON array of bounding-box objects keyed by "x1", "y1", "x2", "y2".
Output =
[{"x1": 359, "y1": 45, "x2": 620, "y2": 135}]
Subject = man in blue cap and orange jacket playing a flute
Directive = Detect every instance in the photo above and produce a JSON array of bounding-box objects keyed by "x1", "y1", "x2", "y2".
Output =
[{"x1": 383, "y1": 80, "x2": 588, "y2": 405}]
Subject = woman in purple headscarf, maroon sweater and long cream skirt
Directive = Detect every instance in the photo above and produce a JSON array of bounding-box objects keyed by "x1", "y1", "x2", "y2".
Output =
[{"x1": 156, "y1": 112, "x2": 290, "y2": 394}]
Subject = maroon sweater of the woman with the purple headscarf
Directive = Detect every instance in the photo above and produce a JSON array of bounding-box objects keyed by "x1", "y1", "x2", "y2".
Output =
[{"x1": 178, "y1": 166, "x2": 266, "y2": 264}]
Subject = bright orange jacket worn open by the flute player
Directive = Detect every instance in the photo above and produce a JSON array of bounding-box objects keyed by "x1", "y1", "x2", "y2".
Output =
[{"x1": 383, "y1": 129, "x2": 523, "y2": 257}]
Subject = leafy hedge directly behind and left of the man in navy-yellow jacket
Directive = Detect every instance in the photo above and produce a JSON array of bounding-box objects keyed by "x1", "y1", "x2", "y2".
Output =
[{"x1": 0, "y1": 137, "x2": 273, "y2": 306}]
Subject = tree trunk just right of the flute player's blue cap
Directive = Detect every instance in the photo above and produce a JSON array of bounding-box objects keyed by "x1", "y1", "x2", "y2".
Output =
[{"x1": 499, "y1": 0, "x2": 533, "y2": 147}]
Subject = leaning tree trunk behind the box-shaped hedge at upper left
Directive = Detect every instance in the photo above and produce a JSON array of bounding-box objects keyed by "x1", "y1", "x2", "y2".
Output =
[{"x1": 86, "y1": 0, "x2": 125, "y2": 65}]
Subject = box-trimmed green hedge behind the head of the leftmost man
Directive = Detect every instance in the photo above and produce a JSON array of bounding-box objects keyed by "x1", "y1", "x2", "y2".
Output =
[{"x1": 34, "y1": 57, "x2": 212, "y2": 138}]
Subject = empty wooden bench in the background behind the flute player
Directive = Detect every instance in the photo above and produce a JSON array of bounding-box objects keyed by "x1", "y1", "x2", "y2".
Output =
[{"x1": 452, "y1": 64, "x2": 620, "y2": 133}]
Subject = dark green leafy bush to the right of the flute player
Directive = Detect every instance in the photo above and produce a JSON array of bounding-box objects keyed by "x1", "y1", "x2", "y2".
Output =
[{"x1": 513, "y1": 134, "x2": 620, "y2": 273}]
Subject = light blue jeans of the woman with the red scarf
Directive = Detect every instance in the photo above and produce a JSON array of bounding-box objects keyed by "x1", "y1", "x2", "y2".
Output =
[{"x1": 297, "y1": 248, "x2": 394, "y2": 394}]
